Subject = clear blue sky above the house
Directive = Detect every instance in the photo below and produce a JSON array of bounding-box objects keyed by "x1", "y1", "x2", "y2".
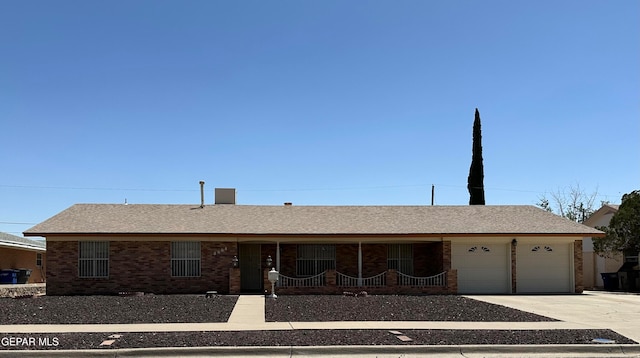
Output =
[{"x1": 0, "y1": 0, "x2": 640, "y2": 235}]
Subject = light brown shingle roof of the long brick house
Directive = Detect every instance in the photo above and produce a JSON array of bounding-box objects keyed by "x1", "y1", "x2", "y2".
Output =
[{"x1": 25, "y1": 204, "x2": 601, "y2": 236}]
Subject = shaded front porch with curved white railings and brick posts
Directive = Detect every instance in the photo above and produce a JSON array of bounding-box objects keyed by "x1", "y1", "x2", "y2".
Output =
[{"x1": 229, "y1": 241, "x2": 458, "y2": 295}]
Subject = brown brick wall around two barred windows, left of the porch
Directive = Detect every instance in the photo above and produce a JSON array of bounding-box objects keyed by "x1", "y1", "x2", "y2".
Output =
[{"x1": 47, "y1": 241, "x2": 237, "y2": 295}]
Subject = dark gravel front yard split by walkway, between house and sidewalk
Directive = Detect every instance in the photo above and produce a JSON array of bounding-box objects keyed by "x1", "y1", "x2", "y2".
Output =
[{"x1": 0, "y1": 295, "x2": 554, "y2": 324}]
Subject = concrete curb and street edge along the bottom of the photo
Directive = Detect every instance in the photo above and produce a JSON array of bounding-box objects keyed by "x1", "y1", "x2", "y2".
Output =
[{"x1": 0, "y1": 344, "x2": 640, "y2": 358}]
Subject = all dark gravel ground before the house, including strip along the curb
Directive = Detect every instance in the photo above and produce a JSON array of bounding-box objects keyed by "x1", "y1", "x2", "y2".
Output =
[{"x1": 0, "y1": 295, "x2": 636, "y2": 350}]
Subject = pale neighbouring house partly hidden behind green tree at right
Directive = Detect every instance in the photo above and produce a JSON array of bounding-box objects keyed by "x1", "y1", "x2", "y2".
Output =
[{"x1": 582, "y1": 204, "x2": 623, "y2": 288}]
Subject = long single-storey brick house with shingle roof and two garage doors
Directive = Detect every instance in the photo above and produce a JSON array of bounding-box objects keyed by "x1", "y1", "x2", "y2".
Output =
[{"x1": 25, "y1": 189, "x2": 602, "y2": 295}]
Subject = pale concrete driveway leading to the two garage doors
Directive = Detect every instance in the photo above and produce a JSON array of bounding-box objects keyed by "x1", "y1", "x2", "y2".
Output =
[{"x1": 466, "y1": 291, "x2": 640, "y2": 343}]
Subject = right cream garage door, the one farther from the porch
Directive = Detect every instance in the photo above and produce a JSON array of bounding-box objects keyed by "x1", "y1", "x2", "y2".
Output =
[{"x1": 516, "y1": 243, "x2": 574, "y2": 293}]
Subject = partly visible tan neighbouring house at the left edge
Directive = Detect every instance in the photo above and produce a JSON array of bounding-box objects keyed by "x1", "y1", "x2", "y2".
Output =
[{"x1": 0, "y1": 232, "x2": 47, "y2": 283}]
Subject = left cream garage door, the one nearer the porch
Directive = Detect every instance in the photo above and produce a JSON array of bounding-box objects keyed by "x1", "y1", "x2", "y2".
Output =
[{"x1": 451, "y1": 244, "x2": 511, "y2": 293}]
